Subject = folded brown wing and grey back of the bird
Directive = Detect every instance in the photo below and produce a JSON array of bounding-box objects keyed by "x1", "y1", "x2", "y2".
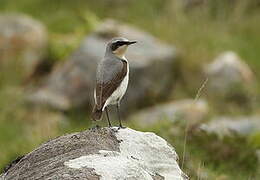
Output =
[{"x1": 96, "y1": 59, "x2": 127, "y2": 110}]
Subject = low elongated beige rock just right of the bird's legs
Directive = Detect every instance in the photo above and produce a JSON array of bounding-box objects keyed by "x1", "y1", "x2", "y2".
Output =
[{"x1": 129, "y1": 99, "x2": 209, "y2": 127}]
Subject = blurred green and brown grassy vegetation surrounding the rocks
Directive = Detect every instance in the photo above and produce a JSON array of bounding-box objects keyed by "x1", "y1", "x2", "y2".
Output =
[{"x1": 0, "y1": 0, "x2": 260, "y2": 180}]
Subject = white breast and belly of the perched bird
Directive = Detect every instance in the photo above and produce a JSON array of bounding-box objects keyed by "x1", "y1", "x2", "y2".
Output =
[{"x1": 94, "y1": 58, "x2": 129, "y2": 111}]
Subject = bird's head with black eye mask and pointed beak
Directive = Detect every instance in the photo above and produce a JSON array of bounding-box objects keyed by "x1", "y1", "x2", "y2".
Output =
[{"x1": 107, "y1": 37, "x2": 136, "y2": 58}]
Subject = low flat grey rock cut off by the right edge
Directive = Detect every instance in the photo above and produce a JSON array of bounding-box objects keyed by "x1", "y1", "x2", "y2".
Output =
[{"x1": 199, "y1": 115, "x2": 260, "y2": 138}]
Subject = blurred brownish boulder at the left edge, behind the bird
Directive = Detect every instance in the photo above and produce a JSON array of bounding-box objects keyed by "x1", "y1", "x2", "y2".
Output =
[{"x1": 0, "y1": 14, "x2": 47, "y2": 76}]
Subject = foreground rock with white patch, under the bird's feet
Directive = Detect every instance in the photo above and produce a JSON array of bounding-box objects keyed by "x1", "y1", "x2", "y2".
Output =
[{"x1": 0, "y1": 128, "x2": 187, "y2": 180}]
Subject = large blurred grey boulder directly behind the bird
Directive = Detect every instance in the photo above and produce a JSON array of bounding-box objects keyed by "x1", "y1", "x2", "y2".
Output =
[{"x1": 30, "y1": 20, "x2": 177, "y2": 110}]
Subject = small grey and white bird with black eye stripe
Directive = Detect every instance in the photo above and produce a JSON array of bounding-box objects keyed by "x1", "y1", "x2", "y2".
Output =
[{"x1": 92, "y1": 37, "x2": 137, "y2": 128}]
